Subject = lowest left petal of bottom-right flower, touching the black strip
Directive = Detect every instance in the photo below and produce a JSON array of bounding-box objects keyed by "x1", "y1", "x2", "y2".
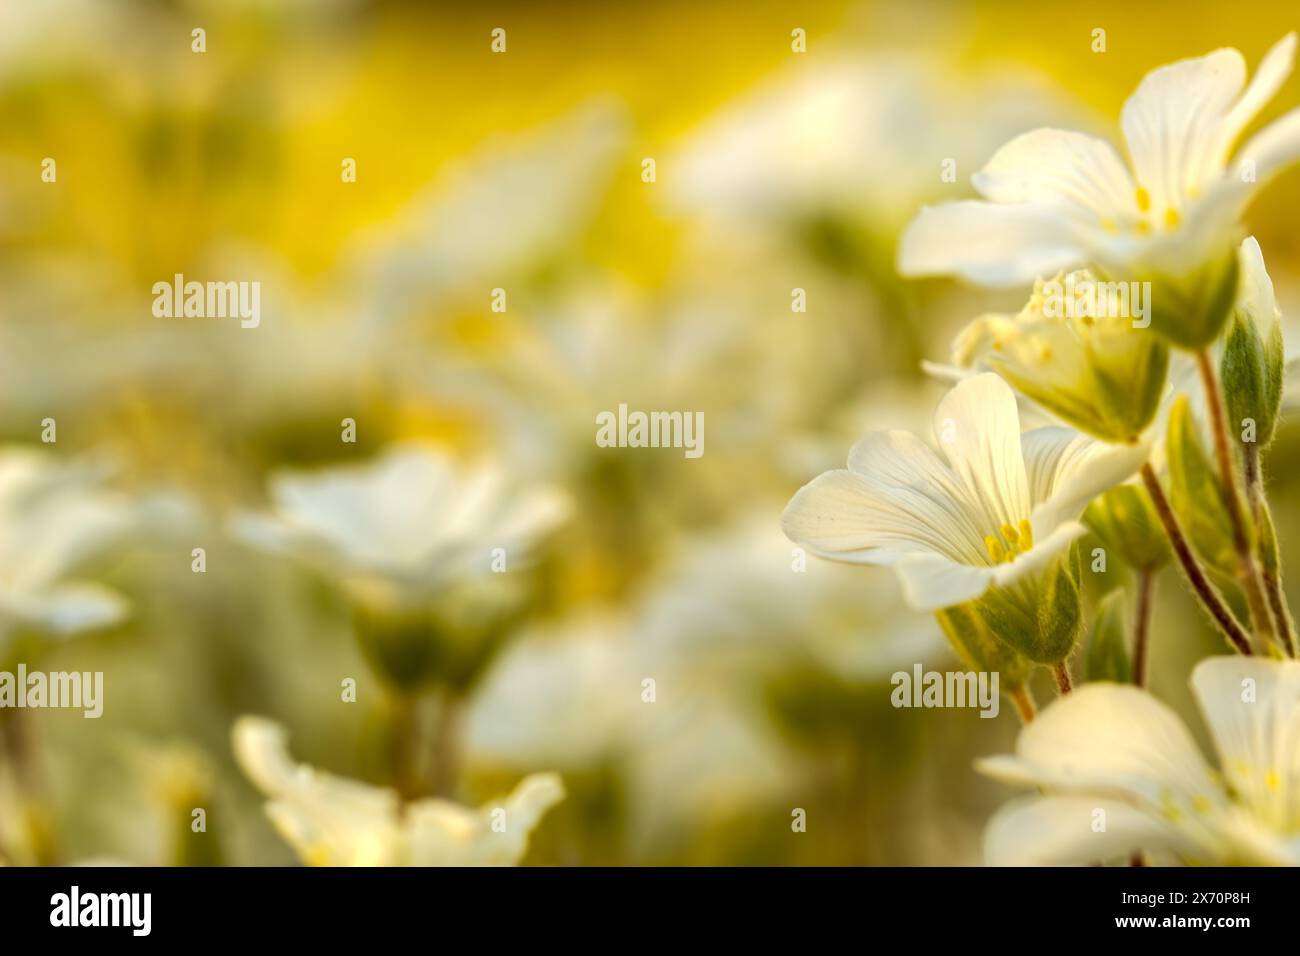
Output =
[{"x1": 984, "y1": 796, "x2": 1193, "y2": 866}]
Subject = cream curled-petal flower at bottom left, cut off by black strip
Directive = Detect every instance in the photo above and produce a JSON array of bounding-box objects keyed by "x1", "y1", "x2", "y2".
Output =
[{"x1": 233, "y1": 717, "x2": 564, "y2": 866}]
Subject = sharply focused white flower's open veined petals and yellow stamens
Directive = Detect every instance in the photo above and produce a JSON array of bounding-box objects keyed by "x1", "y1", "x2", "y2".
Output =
[{"x1": 783, "y1": 373, "x2": 1147, "y2": 610}]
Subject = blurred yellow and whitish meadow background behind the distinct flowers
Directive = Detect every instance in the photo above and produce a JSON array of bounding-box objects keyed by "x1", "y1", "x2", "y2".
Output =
[{"x1": 0, "y1": 0, "x2": 1300, "y2": 865}]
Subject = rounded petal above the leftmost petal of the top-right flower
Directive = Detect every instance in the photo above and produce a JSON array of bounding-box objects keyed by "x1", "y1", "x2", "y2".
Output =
[{"x1": 971, "y1": 129, "x2": 1136, "y2": 219}]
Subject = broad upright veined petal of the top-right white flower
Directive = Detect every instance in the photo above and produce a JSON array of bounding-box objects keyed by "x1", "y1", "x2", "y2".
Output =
[{"x1": 1121, "y1": 49, "x2": 1245, "y2": 210}]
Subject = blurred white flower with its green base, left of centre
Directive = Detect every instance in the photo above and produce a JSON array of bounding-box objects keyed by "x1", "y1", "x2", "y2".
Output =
[{"x1": 235, "y1": 445, "x2": 569, "y2": 691}]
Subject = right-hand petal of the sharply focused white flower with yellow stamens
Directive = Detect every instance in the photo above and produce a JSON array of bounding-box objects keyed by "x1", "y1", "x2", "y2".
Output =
[{"x1": 1021, "y1": 427, "x2": 1149, "y2": 536}]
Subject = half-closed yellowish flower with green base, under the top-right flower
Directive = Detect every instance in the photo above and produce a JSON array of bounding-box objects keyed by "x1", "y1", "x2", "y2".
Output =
[{"x1": 953, "y1": 271, "x2": 1169, "y2": 441}]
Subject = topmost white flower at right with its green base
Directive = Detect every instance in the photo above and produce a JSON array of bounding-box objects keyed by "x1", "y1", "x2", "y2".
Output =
[{"x1": 898, "y1": 34, "x2": 1300, "y2": 347}]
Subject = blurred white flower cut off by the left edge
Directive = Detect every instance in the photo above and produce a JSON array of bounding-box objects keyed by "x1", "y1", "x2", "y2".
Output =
[{"x1": 0, "y1": 449, "x2": 130, "y2": 650}]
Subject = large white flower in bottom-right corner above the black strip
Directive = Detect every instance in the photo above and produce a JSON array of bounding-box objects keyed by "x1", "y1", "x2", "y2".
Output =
[{"x1": 979, "y1": 657, "x2": 1300, "y2": 865}]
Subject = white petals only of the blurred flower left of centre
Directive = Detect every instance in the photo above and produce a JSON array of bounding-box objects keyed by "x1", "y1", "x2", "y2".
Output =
[{"x1": 237, "y1": 445, "x2": 568, "y2": 606}]
